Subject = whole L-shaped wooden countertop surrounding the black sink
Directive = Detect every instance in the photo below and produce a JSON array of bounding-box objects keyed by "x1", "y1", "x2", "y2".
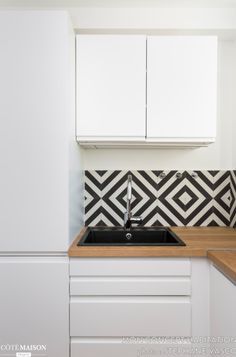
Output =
[{"x1": 68, "y1": 227, "x2": 236, "y2": 281}]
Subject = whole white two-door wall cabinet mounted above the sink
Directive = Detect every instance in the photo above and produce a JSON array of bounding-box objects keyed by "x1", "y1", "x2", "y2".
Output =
[{"x1": 77, "y1": 35, "x2": 217, "y2": 147}]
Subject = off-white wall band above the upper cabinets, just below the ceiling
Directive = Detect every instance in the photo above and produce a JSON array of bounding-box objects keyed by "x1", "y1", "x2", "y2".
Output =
[{"x1": 69, "y1": 6, "x2": 236, "y2": 30}]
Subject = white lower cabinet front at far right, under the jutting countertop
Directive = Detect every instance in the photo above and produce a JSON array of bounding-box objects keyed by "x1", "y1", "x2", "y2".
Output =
[{"x1": 210, "y1": 265, "x2": 236, "y2": 350}]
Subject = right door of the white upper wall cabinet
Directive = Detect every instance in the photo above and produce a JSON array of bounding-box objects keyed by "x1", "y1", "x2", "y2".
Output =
[{"x1": 147, "y1": 36, "x2": 217, "y2": 142}]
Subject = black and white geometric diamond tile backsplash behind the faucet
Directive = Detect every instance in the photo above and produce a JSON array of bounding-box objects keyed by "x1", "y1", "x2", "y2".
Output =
[{"x1": 85, "y1": 170, "x2": 236, "y2": 227}]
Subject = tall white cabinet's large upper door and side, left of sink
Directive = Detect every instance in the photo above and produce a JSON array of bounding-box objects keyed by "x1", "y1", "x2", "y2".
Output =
[{"x1": 0, "y1": 11, "x2": 79, "y2": 252}]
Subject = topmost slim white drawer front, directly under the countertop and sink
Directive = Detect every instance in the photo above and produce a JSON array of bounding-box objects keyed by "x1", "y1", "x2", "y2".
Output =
[{"x1": 70, "y1": 258, "x2": 191, "y2": 276}]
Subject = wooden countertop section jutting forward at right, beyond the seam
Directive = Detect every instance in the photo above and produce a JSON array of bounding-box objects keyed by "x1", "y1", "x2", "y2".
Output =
[{"x1": 207, "y1": 250, "x2": 236, "y2": 283}]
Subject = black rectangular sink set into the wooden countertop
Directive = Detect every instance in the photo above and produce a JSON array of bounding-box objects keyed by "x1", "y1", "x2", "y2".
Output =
[{"x1": 78, "y1": 227, "x2": 185, "y2": 246}]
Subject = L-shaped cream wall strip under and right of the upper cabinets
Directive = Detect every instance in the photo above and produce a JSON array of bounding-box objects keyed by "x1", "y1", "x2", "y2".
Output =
[{"x1": 83, "y1": 40, "x2": 236, "y2": 170}]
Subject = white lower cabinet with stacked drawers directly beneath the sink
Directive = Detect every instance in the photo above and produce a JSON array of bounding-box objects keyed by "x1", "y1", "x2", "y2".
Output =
[{"x1": 70, "y1": 258, "x2": 195, "y2": 357}]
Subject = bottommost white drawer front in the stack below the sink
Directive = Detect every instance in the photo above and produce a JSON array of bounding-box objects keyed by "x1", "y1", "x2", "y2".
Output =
[{"x1": 71, "y1": 337, "x2": 191, "y2": 357}]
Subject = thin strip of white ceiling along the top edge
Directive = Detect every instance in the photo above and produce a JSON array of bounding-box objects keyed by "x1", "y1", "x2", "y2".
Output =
[{"x1": 0, "y1": 0, "x2": 236, "y2": 8}]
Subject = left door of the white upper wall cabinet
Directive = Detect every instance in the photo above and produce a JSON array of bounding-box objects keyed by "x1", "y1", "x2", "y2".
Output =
[{"x1": 77, "y1": 35, "x2": 146, "y2": 141}]
